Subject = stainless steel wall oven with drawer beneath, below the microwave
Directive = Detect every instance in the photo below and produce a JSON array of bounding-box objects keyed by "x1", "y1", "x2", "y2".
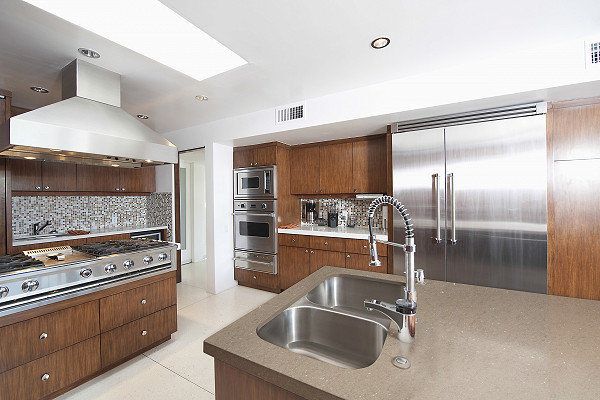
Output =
[{"x1": 233, "y1": 200, "x2": 277, "y2": 274}]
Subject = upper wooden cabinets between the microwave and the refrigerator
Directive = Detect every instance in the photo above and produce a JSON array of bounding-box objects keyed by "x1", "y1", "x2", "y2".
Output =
[{"x1": 290, "y1": 137, "x2": 387, "y2": 195}]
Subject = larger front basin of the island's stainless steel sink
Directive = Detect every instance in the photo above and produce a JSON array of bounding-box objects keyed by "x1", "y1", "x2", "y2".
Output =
[{"x1": 258, "y1": 306, "x2": 388, "y2": 369}]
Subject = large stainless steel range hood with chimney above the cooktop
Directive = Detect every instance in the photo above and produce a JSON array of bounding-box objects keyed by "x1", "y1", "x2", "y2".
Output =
[{"x1": 0, "y1": 60, "x2": 177, "y2": 167}]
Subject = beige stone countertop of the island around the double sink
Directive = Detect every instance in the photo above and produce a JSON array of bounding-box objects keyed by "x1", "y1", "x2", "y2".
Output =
[{"x1": 204, "y1": 267, "x2": 600, "y2": 400}]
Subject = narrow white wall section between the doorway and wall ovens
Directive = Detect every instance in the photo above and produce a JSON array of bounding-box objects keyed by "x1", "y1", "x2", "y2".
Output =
[{"x1": 205, "y1": 143, "x2": 237, "y2": 293}]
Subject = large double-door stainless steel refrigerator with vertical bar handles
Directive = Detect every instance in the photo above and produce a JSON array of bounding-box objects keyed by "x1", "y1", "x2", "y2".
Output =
[{"x1": 392, "y1": 114, "x2": 547, "y2": 293}]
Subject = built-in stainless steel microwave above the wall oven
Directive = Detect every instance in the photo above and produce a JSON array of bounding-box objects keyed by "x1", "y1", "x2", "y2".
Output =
[{"x1": 233, "y1": 165, "x2": 277, "y2": 199}]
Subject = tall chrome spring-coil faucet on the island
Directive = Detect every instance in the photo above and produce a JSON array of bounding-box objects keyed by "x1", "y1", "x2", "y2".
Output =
[{"x1": 364, "y1": 196, "x2": 425, "y2": 343}]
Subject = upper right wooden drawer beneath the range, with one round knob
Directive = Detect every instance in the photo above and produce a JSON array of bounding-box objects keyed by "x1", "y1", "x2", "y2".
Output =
[{"x1": 100, "y1": 278, "x2": 177, "y2": 332}]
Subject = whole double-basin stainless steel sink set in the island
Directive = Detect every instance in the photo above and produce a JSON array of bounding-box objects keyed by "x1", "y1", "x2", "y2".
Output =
[{"x1": 257, "y1": 275, "x2": 404, "y2": 369}]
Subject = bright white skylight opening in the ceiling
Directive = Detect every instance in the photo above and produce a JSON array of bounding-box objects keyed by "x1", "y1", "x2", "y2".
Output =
[{"x1": 25, "y1": 0, "x2": 246, "y2": 81}]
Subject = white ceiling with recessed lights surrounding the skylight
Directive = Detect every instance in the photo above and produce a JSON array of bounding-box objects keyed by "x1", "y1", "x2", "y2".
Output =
[{"x1": 0, "y1": 0, "x2": 600, "y2": 140}]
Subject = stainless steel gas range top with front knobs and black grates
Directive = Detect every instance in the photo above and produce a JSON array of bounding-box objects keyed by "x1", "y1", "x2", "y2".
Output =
[{"x1": 0, "y1": 239, "x2": 177, "y2": 316}]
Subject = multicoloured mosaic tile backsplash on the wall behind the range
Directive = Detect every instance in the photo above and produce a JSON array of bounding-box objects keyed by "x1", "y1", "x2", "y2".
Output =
[{"x1": 12, "y1": 193, "x2": 171, "y2": 237}]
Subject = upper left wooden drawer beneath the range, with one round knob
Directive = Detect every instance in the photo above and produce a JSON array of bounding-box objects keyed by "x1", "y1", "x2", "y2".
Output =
[{"x1": 0, "y1": 301, "x2": 100, "y2": 372}]
